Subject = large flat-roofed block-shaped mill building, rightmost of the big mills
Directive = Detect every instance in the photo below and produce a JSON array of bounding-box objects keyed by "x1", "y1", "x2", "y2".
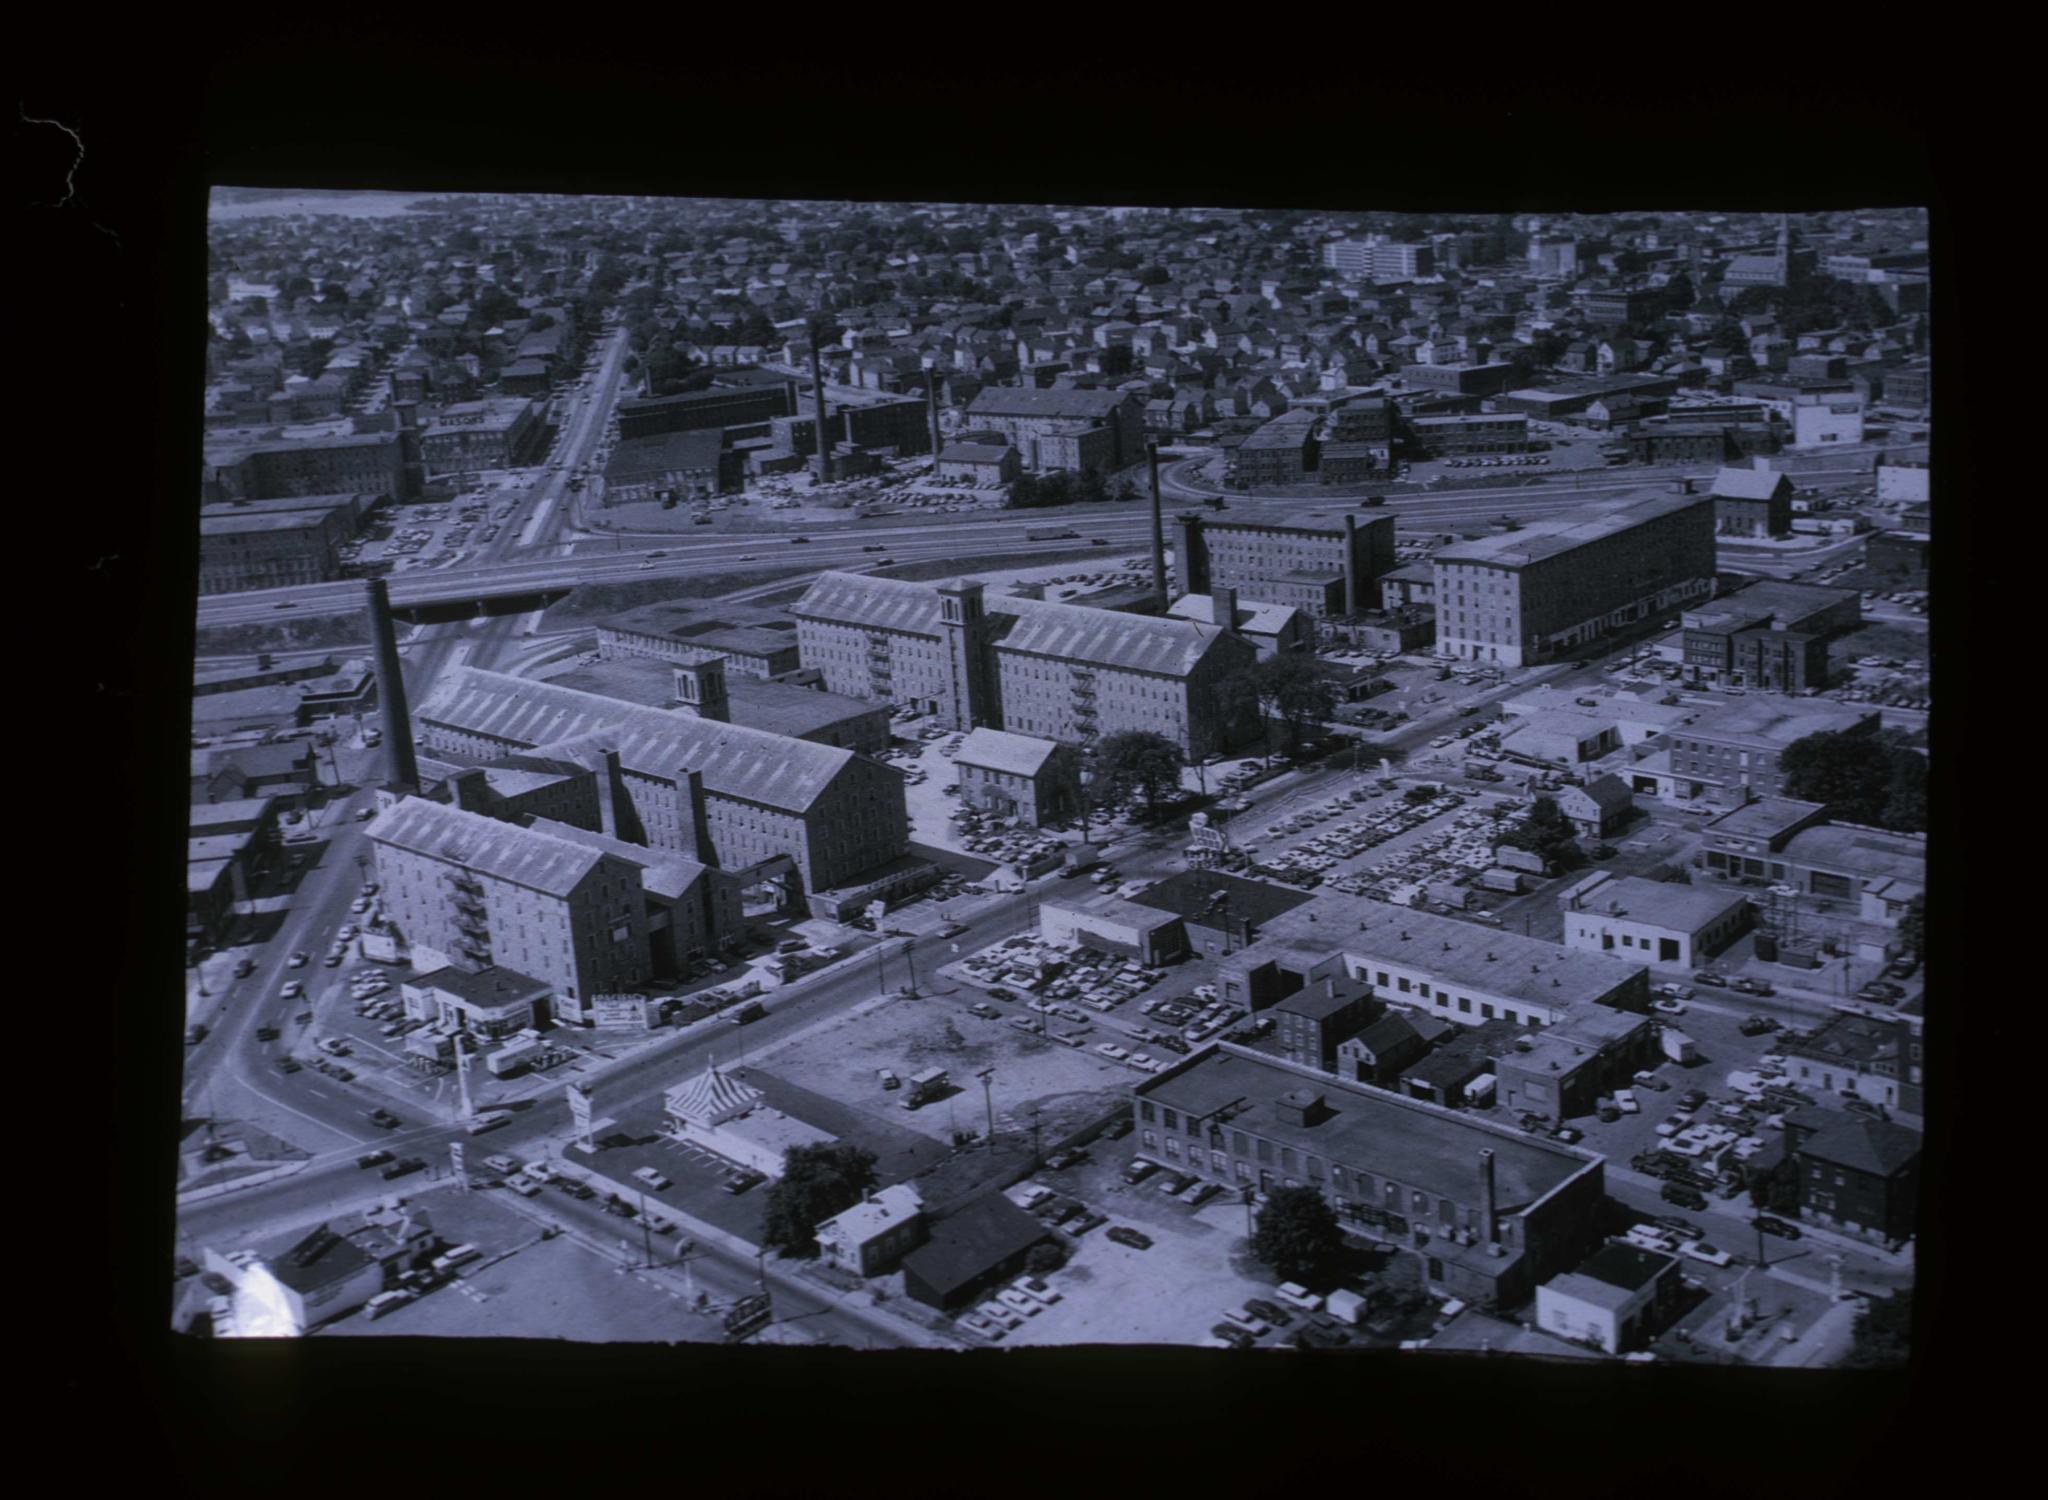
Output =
[{"x1": 1432, "y1": 494, "x2": 1714, "y2": 666}]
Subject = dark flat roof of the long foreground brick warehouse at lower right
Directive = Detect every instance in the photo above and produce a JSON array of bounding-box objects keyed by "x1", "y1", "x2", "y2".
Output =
[{"x1": 1137, "y1": 1047, "x2": 1599, "y2": 1213}]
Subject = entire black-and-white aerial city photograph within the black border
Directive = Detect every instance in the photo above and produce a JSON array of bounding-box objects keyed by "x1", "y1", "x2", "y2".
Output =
[{"x1": 164, "y1": 186, "x2": 1916, "y2": 1381}]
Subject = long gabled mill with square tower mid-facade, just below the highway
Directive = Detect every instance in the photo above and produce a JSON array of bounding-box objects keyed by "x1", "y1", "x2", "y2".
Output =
[{"x1": 791, "y1": 574, "x2": 1257, "y2": 756}]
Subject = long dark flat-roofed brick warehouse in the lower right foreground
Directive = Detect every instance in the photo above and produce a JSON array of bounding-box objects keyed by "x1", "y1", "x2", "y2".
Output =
[{"x1": 1133, "y1": 1043, "x2": 1604, "y2": 1305}]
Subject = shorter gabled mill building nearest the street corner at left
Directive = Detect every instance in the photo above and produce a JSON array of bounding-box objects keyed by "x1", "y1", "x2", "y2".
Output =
[{"x1": 369, "y1": 797, "x2": 651, "y2": 1020}]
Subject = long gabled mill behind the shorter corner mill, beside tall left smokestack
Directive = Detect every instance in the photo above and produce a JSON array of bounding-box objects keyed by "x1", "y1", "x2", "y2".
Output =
[{"x1": 416, "y1": 668, "x2": 909, "y2": 904}]
